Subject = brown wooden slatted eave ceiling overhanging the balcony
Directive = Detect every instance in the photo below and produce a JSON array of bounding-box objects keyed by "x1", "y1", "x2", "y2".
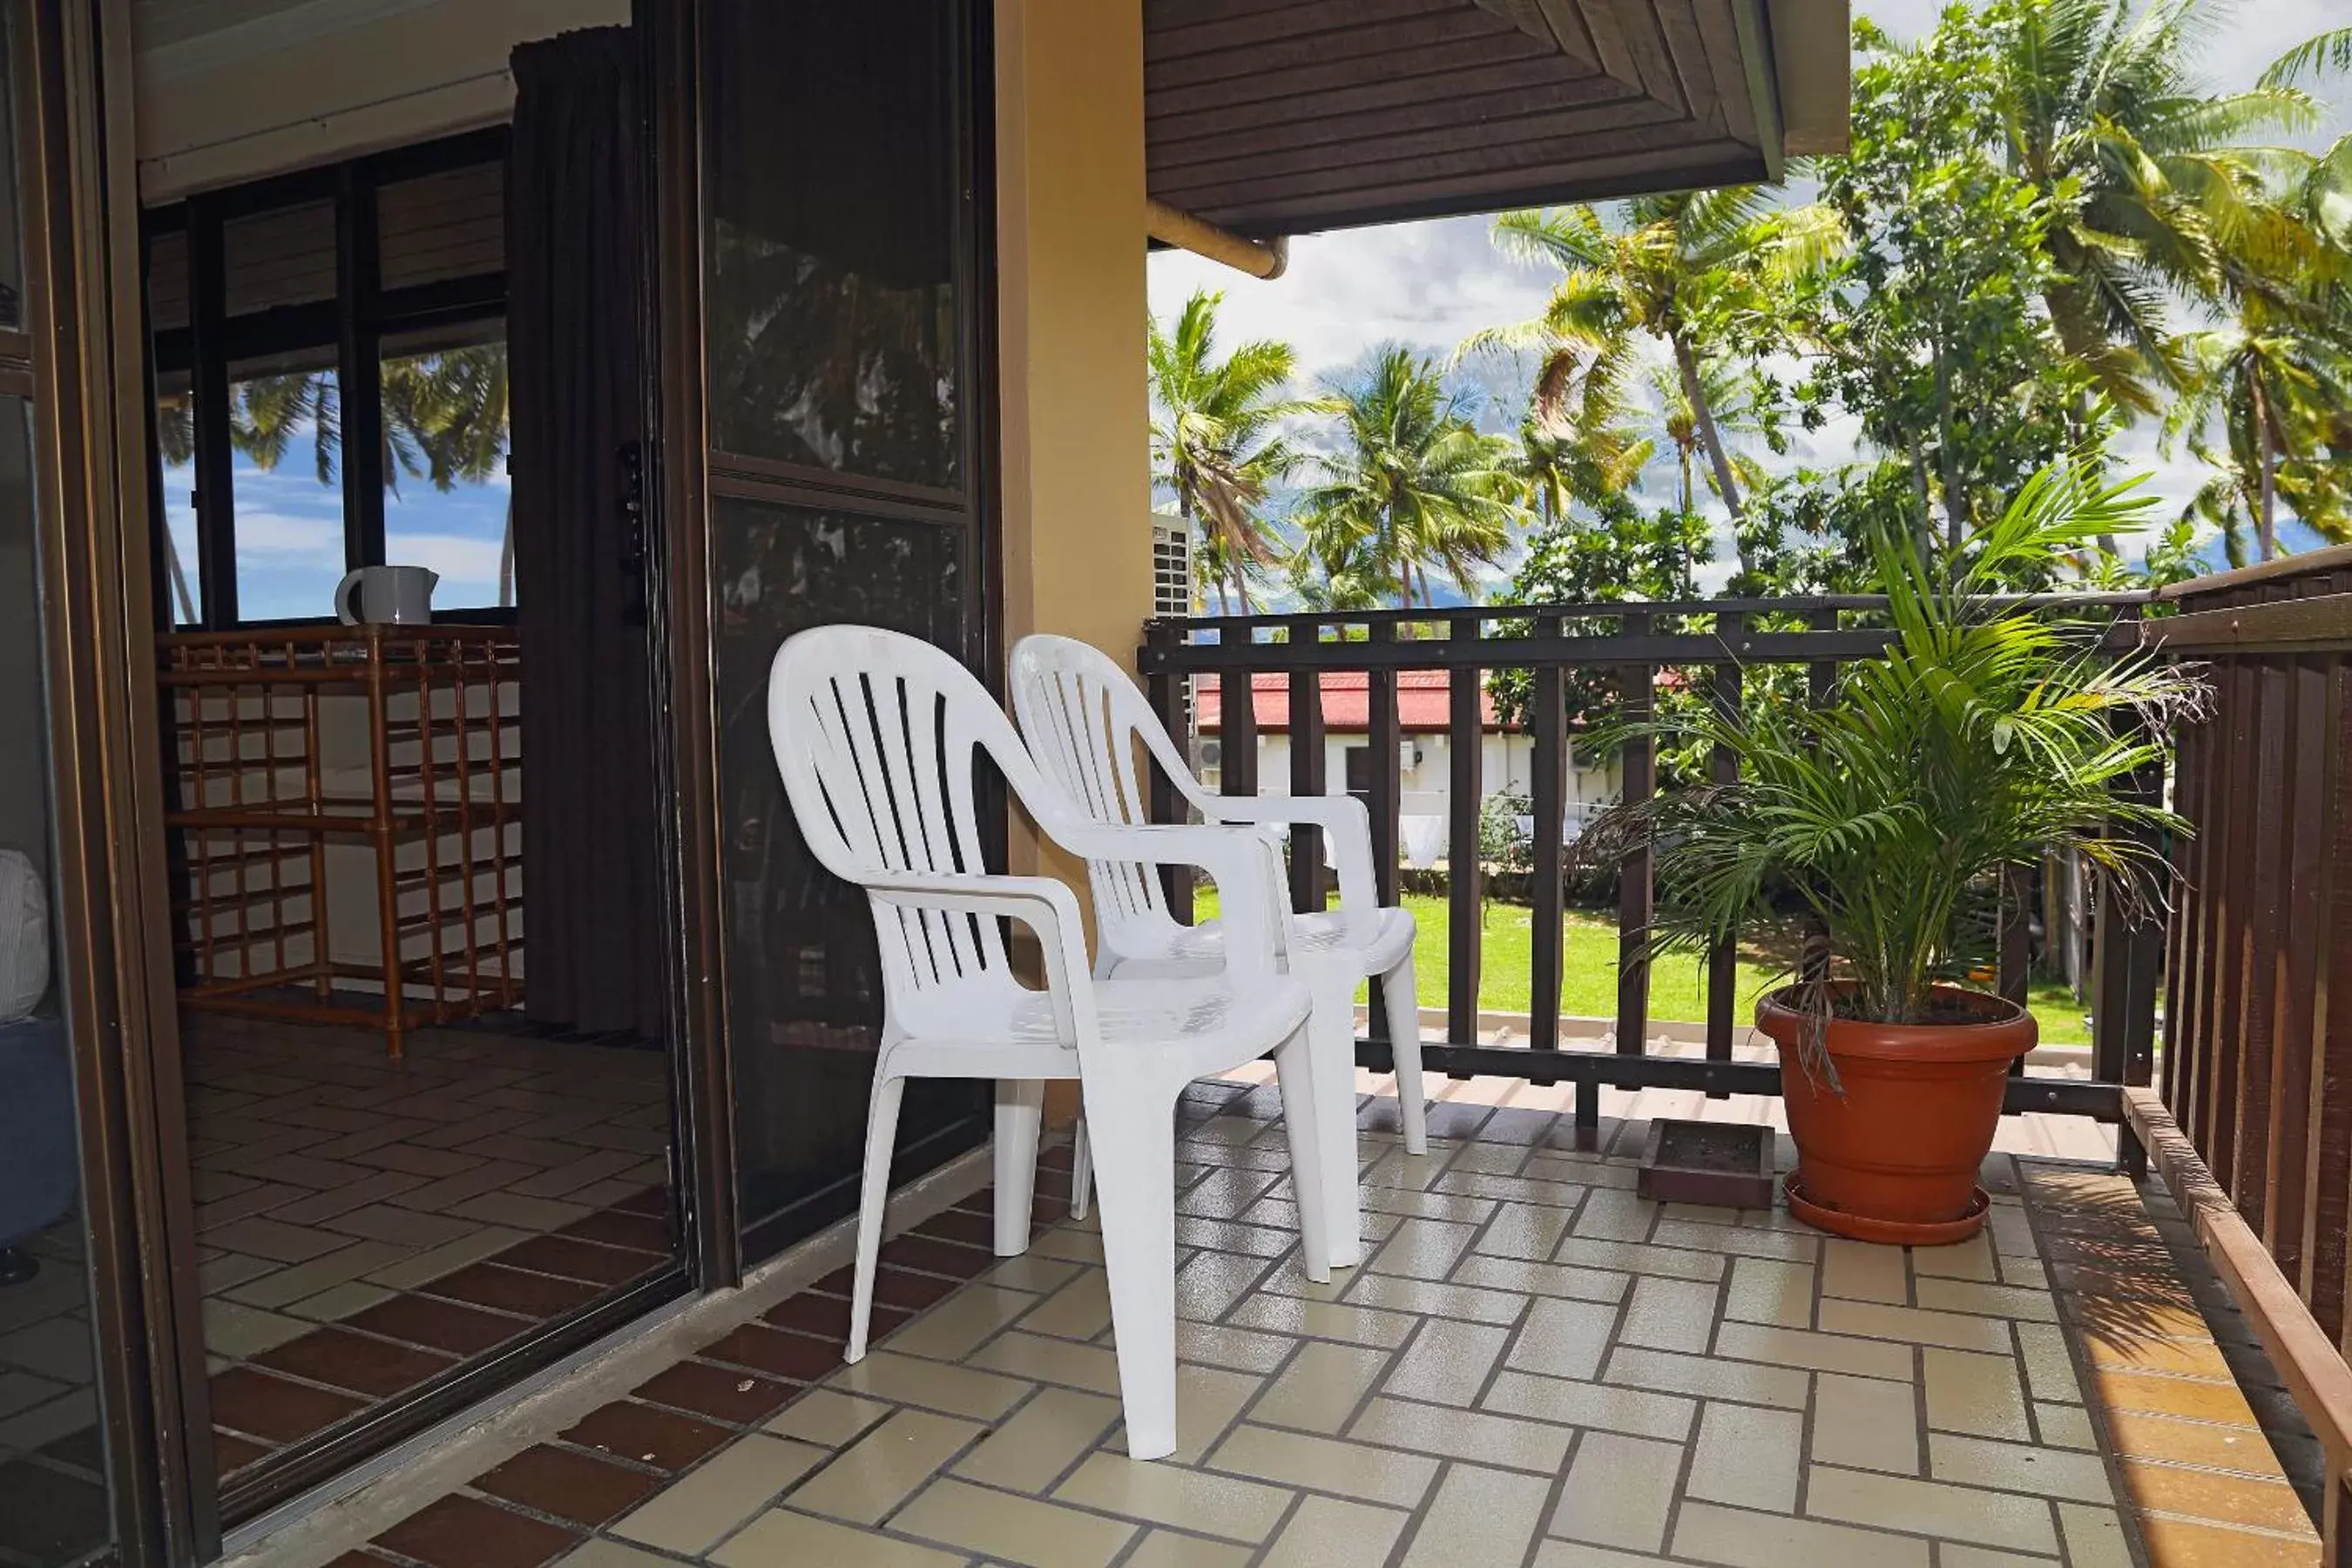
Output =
[{"x1": 1143, "y1": 0, "x2": 1847, "y2": 235}]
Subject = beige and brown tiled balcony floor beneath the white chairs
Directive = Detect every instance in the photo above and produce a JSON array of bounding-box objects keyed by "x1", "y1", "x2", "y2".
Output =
[{"x1": 321, "y1": 1084, "x2": 2317, "y2": 1568}]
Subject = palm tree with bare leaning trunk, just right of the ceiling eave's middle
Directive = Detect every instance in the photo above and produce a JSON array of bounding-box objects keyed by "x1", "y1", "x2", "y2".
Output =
[{"x1": 1465, "y1": 186, "x2": 1839, "y2": 569}]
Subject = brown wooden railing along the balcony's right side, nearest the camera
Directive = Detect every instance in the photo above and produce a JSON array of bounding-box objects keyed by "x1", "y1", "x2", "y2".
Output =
[{"x1": 2129, "y1": 548, "x2": 2352, "y2": 1564}]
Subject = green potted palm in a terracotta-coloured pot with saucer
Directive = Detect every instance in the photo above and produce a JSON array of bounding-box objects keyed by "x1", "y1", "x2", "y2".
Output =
[{"x1": 1585, "y1": 468, "x2": 2201, "y2": 1244}]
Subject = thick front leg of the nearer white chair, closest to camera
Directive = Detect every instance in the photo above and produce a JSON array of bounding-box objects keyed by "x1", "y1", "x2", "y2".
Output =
[{"x1": 1086, "y1": 1084, "x2": 1176, "y2": 1460}]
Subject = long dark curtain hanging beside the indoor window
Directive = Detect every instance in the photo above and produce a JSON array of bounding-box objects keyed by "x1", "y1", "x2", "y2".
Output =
[{"x1": 506, "y1": 28, "x2": 666, "y2": 1039}]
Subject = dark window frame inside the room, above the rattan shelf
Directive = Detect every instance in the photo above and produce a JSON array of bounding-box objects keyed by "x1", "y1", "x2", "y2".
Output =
[{"x1": 141, "y1": 125, "x2": 515, "y2": 630}]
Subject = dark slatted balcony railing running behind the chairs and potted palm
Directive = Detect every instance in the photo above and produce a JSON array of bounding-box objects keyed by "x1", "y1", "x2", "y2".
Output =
[{"x1": 1139, "y1": 592, "x2": 2154, "y2": 1132}]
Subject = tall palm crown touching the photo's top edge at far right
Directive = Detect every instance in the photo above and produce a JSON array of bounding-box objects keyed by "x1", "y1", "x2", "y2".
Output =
[{"x1": 2002, "y1": 0, "x2": 2319, "y2": 414}]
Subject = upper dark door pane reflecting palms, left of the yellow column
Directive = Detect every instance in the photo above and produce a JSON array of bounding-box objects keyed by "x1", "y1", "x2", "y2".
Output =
[{"x1": 708, "y1": 0, "x2": 964, "y2": 487}]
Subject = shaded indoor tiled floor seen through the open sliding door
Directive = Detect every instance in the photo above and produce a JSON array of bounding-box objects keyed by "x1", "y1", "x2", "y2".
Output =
[{"x1": 184, "y1": 1016, "x2": 671, "y2": 1474}]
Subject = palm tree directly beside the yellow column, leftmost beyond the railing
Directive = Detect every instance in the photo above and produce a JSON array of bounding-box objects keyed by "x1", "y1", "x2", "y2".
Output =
[{"x1": 1148, "y1": 289, "x2": 1310, "y2": 616}]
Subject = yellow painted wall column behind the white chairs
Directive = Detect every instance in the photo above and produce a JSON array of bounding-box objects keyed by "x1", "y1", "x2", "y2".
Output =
[{"x1": 995, "y1": 0, "x2": 1152, "y2": 1119}]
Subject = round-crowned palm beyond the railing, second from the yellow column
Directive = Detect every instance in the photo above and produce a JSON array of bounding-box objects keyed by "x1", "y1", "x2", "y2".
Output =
[{"x1": 1296, "y1": 343, "x2": 1524, "y2": 606}]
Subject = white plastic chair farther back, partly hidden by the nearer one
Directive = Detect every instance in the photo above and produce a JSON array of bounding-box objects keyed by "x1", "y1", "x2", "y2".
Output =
[{"x1": 1011, "y1": 635, "x2": 1430, "y2": 1267}]
